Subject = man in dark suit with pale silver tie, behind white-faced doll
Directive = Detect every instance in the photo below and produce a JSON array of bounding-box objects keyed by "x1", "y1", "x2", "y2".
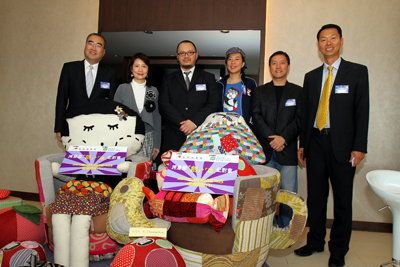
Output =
[{"x1": 54, "y1": 33, "x2": 116, "y2": 141}]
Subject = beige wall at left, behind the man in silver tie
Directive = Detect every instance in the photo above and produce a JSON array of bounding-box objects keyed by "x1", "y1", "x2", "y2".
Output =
[{"x1": 0, "y1": 0, "x2": 99, "y2": 192}]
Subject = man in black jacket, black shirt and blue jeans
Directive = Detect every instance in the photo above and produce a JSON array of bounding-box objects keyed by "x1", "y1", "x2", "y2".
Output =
[{"x1": 252, "y1": 51, "x2": 301, "y2": 227}]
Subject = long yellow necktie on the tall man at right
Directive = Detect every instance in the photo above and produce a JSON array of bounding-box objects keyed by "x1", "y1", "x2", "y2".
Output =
[{"x1": 316, "y1": 66, "x2": 332, "y2": 130}]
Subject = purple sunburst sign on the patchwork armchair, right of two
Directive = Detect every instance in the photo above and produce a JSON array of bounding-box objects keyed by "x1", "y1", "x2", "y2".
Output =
[{"x1": 163, "y1": 152, "x2": 239, "y2": 195}]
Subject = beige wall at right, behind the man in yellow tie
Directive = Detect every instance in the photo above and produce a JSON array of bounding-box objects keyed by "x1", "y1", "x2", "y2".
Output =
[{"x1": 265, "y1": 0, "x2": 400, "y2": 222}]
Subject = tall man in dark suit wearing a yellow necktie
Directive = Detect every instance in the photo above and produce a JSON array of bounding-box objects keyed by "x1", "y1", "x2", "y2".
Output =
[{"x1": 295, "y1": 24, "x2": 369, "y2": 267}]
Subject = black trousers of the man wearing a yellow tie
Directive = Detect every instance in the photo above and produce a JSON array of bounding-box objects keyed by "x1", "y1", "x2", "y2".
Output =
[{"x1": 307, "y1": 130, "x2": 355, "y2": 257}]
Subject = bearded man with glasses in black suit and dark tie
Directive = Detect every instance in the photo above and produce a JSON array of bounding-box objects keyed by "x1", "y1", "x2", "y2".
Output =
[{"x1": 159, "y1": 40, "x2": 221, "y2": 153}]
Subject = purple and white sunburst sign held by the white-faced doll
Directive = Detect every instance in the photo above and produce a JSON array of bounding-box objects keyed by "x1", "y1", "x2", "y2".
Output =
[{"x1": 59, "y1": 146, "x2": 127, "y2": 175}]
